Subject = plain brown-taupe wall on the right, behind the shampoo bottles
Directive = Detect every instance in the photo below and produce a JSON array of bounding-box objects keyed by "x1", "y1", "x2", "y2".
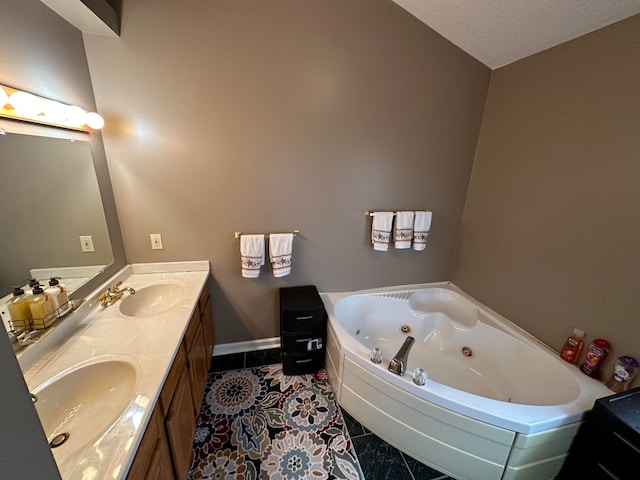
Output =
[{"x1": 451, "y1": 16, "x2": 640, "y2": 375}]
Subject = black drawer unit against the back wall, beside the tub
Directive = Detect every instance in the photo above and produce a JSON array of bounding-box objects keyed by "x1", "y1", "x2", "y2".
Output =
[{"x1": 280, "y1": 285, "x2": 327, "y2": 375}]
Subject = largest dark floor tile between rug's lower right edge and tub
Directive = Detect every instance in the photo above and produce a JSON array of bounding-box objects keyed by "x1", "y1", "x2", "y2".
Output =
[{"x1": 351, "y1": 433, "x2": 413, "y2": 480}]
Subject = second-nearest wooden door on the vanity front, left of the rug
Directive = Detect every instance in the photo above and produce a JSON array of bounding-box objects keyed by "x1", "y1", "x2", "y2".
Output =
[{"x1": 165, "y1": 367, "x2": 196, "y2": 478}]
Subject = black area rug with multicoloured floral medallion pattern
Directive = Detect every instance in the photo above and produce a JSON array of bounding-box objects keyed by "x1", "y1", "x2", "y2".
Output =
[{"x1": 188, "y1": 364, "x2": 364, "y2": 480}]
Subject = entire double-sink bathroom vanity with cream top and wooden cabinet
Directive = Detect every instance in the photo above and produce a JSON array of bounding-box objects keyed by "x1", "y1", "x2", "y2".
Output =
[{"x1": 17, "y1": 261, "x2": 214, "y2": 480}]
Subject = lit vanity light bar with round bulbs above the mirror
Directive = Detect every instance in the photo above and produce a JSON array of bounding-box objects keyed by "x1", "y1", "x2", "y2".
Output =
[{"x1": 0, "y1": 85, "x2": 104, "y2": 132}]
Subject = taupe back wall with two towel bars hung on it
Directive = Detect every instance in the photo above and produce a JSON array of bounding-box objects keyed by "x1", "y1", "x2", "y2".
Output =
[{"x1": 85, "y1": 0, "x2": 490, "y2": 343}]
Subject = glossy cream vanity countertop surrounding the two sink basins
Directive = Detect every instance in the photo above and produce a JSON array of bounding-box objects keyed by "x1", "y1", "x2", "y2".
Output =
[{"x1": 17, "y1": 261, "x2": 209, "y2": 480}]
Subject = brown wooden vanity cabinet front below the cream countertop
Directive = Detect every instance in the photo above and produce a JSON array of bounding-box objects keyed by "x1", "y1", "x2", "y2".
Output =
[{"x1": 127, "y1": 286, "x2": 214, "y2": 480}]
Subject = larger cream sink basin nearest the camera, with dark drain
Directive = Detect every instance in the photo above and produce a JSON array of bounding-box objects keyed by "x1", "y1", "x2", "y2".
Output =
[{"x1": 33, "y1": 359, "x2": 138, "y2": 458}]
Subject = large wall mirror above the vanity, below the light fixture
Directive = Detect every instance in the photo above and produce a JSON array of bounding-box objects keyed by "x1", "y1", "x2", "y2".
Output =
[{"x1": 0, "y1": 127, "x2": 114, "y2": 330}]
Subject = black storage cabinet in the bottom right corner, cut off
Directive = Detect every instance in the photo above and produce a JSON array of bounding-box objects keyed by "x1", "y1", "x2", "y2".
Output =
[{"x1": 556, "y1": 387, "x2": 640, "y2": 480}]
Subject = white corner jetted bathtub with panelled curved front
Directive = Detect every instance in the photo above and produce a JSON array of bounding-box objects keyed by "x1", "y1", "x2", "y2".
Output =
[{"x1": 321, "y1": 282, "x2": 612, "y2": 480}]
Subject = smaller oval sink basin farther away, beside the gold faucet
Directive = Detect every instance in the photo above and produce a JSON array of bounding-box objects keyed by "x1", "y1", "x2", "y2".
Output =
[{"x1": 120, "y1": 283, "x2": 186, "y2": 317}]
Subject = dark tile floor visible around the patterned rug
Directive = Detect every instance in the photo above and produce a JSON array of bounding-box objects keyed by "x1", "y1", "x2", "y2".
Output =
[{"x1": 211, "y1": 348, "x2": 452, "y2": 480}]
